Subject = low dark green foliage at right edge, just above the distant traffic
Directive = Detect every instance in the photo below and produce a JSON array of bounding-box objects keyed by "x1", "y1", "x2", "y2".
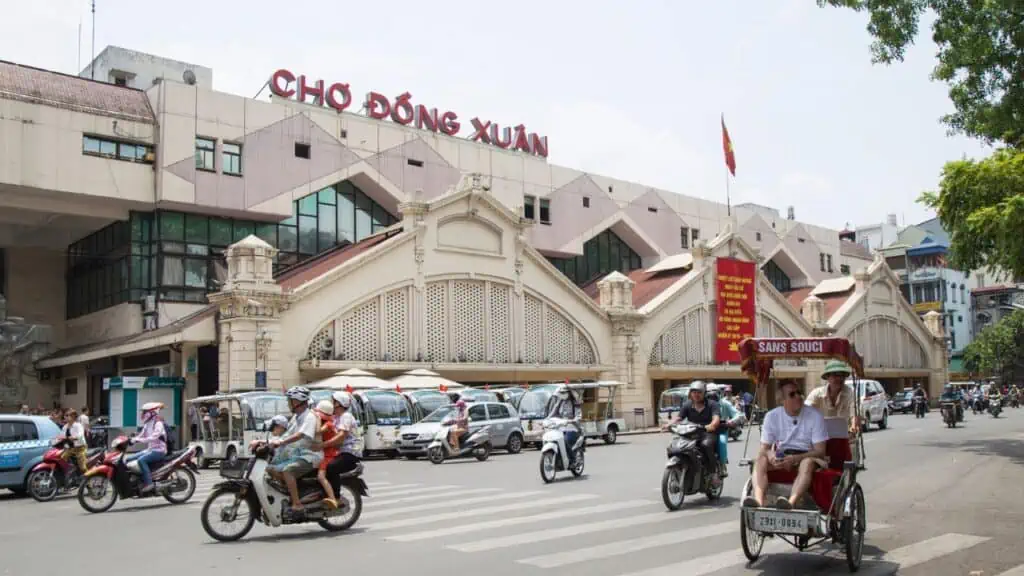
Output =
[{"x1": 964, "y1": 311, "x2": 1024, "y2": 382}]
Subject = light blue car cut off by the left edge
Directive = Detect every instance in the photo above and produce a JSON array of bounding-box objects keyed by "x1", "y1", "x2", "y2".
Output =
[{"x1": 0, "y1": 414, "x2": 60, "y2": 496}]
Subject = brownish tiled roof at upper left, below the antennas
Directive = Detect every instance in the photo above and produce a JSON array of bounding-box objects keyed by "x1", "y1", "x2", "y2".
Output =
[{"x1": 0, "y1": 60, "x2": 157, "y2": 124}]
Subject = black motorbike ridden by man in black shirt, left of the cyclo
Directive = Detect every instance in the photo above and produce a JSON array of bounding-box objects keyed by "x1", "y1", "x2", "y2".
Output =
[{"x1": 662, "y1": 423, "x2": 724, "y2": 510}]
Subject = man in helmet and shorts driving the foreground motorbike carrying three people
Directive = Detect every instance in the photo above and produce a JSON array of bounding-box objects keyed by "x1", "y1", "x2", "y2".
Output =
[{"x1": 267, "y1": 386, "x2": 323, "y2": 513}]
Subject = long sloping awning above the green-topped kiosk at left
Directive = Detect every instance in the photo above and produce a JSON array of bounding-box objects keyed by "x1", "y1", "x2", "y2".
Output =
[{"x1": 36, "y1": 305, "x2": 217, "y2": 370}]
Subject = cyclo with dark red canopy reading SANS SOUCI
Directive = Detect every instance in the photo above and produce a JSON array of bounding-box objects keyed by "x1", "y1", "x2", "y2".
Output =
[{"x1": 739, "y1": 337, "x2": 867, "y2": 572}]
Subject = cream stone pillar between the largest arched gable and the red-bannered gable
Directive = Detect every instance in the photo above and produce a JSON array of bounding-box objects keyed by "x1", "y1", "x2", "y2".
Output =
[{"x1": 597, "y1": 272, "x2": 643, "y2": 427}]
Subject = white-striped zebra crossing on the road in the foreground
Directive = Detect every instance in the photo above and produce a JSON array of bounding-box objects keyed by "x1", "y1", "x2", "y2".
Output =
[{"x1": 187, "y1": 475, "x2": 1024, "y2": 576}]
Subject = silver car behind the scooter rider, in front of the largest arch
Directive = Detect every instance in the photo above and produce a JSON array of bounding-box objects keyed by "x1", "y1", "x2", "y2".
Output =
[{"x1": 397, "y1": 402, "x2": 522, "y2": 460}]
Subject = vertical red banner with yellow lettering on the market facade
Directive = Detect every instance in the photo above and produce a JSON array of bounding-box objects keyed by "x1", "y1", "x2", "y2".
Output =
[{"x1": 715, "y1": 258, "x2": 757, "y2": 363}]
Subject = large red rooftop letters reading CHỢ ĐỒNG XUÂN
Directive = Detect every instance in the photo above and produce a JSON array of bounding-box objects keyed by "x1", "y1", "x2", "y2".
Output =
[{"x1": 270, "y1": 69, "x2": 548, "y2": 158}]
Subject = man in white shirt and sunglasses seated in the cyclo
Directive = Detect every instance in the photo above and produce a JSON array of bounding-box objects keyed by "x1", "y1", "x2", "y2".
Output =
[{"x1": 743, "y1": 380, "x2": 828, "y2": 509}]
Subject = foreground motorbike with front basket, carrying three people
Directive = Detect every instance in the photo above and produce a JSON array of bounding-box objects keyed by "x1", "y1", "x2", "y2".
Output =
[{"x1": 200, "y1": 444, "x2": 369, "y2": 542}]
